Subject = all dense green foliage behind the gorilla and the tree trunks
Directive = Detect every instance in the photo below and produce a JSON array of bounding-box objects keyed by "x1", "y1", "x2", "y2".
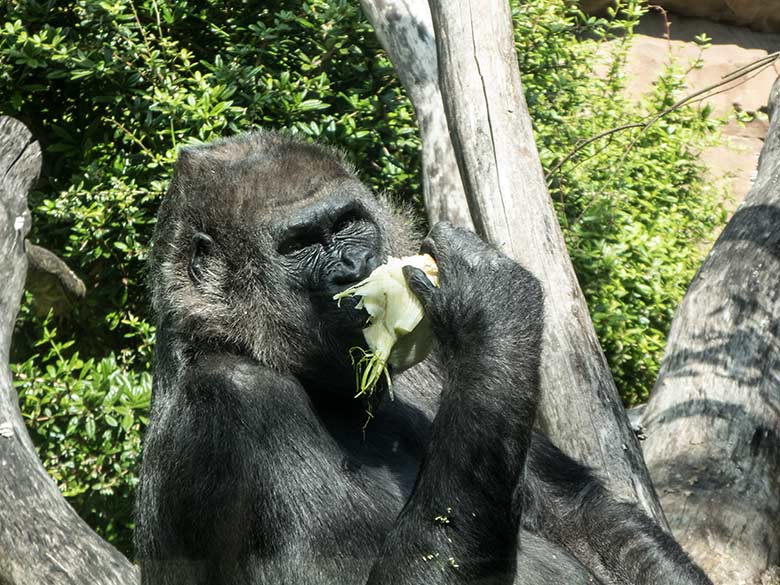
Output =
[{"x1": 0, "y1": 0, "x2": 722, "y2": 551}]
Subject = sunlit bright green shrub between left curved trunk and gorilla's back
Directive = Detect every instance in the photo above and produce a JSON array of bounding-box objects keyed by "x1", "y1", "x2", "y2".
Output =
[{"x1": 14, "y1": 312, "x2": 152, "y2": 554}]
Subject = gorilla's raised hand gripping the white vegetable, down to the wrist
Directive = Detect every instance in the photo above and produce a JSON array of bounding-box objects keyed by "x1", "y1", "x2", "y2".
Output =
[{"x1": 404, "y1": 222, "x2": 543, "y2": 363}]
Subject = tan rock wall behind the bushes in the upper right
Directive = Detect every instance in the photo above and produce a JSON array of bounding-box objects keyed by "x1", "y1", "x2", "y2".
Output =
[{"x1": 582, "y1": 0, "x2": 780, "y2": 210}]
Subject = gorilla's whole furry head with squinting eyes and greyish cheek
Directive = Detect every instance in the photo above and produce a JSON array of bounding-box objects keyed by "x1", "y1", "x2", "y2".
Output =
[{"x1": 151, "y1": 133, "x2": 411, "y2": 387}]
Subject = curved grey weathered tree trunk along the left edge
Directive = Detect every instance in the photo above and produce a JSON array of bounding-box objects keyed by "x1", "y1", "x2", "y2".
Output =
[{"x1": 0, "y1": 117, "x2": 138, "y2": 585}]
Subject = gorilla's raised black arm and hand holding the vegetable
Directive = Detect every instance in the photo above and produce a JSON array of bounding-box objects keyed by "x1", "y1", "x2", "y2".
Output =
[{"x1": 369, "y1": 224, "x2": 543, "y2": 585}]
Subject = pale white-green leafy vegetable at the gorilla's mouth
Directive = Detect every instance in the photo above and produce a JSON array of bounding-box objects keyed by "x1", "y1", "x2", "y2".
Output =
[{"x1": 333, "y1": 254, "x2": 439, "y2": 396}]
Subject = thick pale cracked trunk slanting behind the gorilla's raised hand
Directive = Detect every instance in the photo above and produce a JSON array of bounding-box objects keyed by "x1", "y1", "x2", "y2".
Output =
[{"x1": 430, "y1": 0, "x2": 666, "y2": 526}]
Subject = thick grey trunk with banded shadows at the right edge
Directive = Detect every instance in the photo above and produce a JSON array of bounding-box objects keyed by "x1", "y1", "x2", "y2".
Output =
[{"x1": 643, "y1": 79, "x2": 780, "y2": 585}]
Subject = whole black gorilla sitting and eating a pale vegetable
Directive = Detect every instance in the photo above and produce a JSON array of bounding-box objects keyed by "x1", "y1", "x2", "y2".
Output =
[{"x1": 135, "y1": 131, "x2": 710, "y2": 585}]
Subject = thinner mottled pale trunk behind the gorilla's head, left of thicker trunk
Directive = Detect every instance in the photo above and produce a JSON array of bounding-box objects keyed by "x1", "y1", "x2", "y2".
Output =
[{"x1": 360, "y1": 0, "x2": 474, "y2": 229}]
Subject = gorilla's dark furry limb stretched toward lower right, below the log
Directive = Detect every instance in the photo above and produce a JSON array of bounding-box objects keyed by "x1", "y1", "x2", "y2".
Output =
[{"x1": 523, "y1": 433, "x2": 712, "y2": 585}]
